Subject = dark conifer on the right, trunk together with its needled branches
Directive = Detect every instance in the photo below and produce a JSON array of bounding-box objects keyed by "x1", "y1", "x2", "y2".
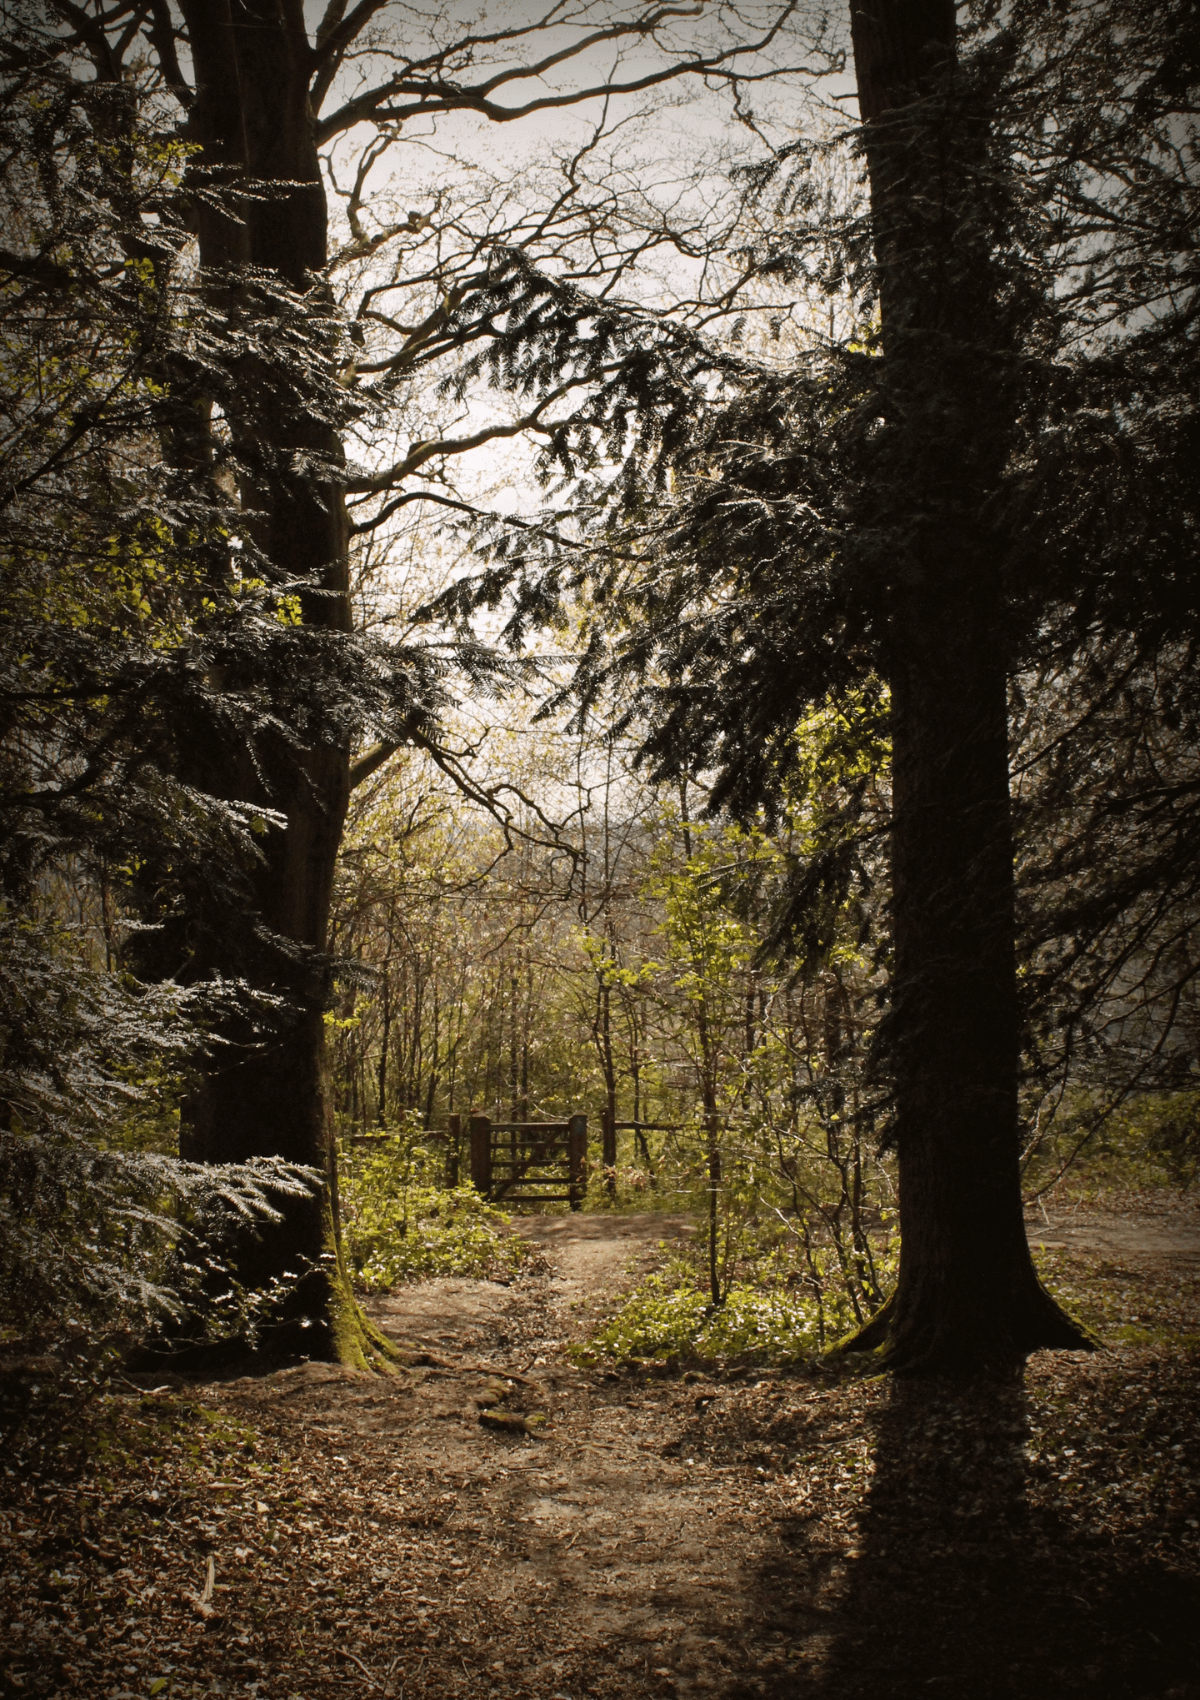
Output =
[{"x1": 462, "y1": 0, "x2": 1198, "y2": 1372}]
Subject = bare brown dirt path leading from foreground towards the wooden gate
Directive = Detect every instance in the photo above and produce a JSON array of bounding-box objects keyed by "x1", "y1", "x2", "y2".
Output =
[{"x1": 212, "y1": 1216, "x2": 782, "y2": 1700}]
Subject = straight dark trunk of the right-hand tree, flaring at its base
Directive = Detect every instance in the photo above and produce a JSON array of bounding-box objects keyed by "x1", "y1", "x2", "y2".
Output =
[{"x1": 846, "y1": 0, "x2": 1088, "y2": 1370}]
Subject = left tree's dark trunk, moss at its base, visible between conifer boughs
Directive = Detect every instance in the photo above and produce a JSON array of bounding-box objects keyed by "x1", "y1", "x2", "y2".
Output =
[{"x1": 175, "y1": 0, "x2": 386, "y2": 1363}]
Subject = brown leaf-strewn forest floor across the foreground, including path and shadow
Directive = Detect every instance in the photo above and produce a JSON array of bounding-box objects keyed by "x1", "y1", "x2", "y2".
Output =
[{"x1": 0, "y1": 1195, "x2": 1200, "y2": 1700}]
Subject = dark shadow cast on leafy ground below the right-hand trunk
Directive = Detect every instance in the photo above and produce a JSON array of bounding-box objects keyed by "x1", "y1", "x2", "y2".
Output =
[{"x1": 727, "y1": 1379, "x2": 1200, "y2": 1700}]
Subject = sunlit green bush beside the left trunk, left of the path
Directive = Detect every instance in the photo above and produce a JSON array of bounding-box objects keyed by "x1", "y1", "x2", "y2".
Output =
[{"x1": 340, "y1": 1131, "x2": 532, "y2": 1292}]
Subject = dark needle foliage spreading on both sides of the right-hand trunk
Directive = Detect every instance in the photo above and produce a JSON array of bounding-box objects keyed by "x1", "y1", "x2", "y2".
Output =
[{"x1": 445, "y1": 0, "x2": 1200, "y2": 1128}]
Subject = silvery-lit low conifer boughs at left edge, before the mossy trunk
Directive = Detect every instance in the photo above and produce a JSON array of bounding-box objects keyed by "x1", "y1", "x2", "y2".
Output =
[{"x1": 0, "y1": 906, "x2": 316, "y2": 1350}]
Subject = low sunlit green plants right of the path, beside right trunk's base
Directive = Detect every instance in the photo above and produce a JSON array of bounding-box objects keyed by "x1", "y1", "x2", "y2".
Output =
[{"x1": 575, "y1": 1258, "x2": 857, "y2": 1365}]
